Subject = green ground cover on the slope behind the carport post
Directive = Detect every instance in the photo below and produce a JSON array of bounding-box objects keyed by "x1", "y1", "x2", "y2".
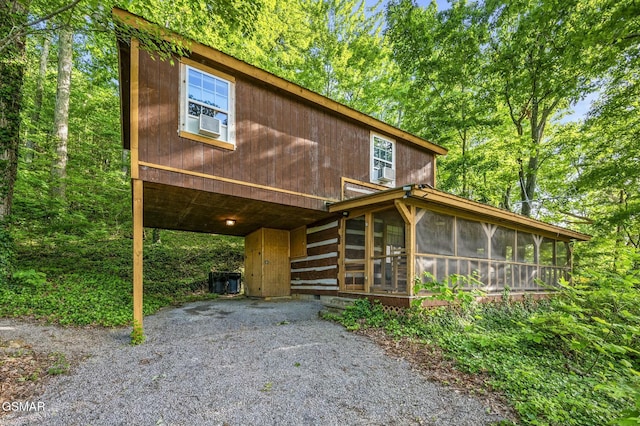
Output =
[{"x1": 0, "y1": 231, "x2": 244, "y2": 326}]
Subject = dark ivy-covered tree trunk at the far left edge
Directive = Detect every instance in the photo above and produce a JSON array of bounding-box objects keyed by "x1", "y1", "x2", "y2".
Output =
[{"x1": 0, "y1": 0, "x2": 27, "y2": 286}]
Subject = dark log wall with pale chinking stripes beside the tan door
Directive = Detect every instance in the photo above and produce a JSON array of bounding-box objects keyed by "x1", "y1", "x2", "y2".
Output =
[{"x1": 291, "y1": 220, "x2": 339, "y2": 294}]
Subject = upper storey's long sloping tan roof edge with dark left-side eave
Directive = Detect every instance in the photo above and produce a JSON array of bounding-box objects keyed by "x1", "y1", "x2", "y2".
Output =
[{"x1": 112, "y1": 8, "x2": 447, "y2": 155}]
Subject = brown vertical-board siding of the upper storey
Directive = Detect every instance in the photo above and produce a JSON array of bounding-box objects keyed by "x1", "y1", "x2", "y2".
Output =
[{"x1": 139, "y1": 51, "x2": 433, "y2": 210}]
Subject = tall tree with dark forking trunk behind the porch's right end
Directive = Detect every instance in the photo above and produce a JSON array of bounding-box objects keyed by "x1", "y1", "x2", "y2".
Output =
[{"x1": 484, "y1": 0, "x2": 636, "y2": 216}]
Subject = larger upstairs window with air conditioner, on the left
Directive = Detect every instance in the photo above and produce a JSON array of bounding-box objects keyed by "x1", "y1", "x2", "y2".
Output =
[{"x1": 180, "y1": 61, "x2": 235, "y2": 148}]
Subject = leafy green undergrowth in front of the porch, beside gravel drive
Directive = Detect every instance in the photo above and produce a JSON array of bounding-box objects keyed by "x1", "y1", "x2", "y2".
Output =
[{"x1": 334, "y1": 272, "x2": 640, "y2": 425}]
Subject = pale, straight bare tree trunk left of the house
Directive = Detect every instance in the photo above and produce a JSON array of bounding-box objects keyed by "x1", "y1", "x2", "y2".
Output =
[{"x1": 52, "y1": 28, "x2": 73, "y2": 198}]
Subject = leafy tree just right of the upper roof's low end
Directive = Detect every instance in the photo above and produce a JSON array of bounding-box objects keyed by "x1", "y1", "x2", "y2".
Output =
[{"x1": 386, "y1": 0, "x2": 497, "y2": 201}]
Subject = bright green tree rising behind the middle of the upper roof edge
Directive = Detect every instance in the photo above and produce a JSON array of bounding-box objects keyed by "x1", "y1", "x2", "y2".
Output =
[{"x1": 294, "y1": 0, "x2": 398, "y2": 120}]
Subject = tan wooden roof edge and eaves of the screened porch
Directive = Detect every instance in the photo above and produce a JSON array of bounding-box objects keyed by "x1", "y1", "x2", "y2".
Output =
[{"x1": 329, "y1": 185, "x2": 591, "y2": 241}]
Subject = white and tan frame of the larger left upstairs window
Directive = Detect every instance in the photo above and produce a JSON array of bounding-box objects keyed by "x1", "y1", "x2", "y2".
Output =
[{"x1": 178, "y1": 58, "x2": 236, "y2": 149}]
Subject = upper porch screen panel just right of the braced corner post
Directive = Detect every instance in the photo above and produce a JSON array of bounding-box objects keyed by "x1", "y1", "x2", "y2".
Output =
[{"x1": 416, "y1": 209, "x2": 454, "y2": 256}]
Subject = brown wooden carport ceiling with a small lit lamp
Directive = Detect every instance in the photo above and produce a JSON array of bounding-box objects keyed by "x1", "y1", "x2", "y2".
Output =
[{"x1": 143, "y1": 182, "x2": 336, "y2": 236}]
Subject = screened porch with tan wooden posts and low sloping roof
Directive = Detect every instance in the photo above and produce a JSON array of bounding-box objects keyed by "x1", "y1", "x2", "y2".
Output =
[{"x1": 329, "y1": 185, "x2": 590, "y2": 306}]
